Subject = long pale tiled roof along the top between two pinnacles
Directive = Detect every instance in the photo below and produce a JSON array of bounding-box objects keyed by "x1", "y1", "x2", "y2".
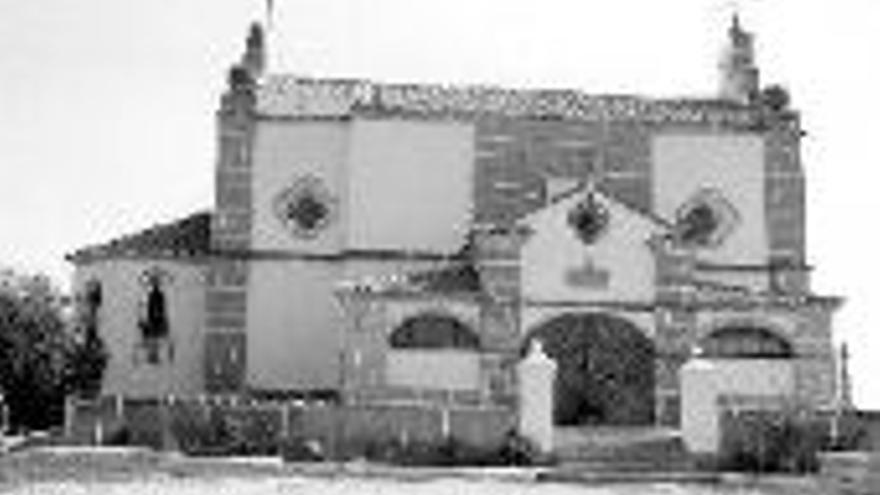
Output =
[{"x1": 257, "y1": 75, "x2": 755, "y2": 124}]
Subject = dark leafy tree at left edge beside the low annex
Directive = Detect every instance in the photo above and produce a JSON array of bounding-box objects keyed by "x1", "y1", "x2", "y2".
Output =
[{"x1": 0, "y1": 270, "x2": 107, "y2": 429}]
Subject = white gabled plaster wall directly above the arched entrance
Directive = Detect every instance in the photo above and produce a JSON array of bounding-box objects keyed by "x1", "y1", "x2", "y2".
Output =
[{"x1": 520, "y1": 194, "x2": 655, "y2": 302}]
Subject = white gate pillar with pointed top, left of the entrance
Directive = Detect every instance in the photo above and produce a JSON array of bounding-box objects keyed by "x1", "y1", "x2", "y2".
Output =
[{"x1": 517, "y1": 339, "x2": 556, "y2": 452}]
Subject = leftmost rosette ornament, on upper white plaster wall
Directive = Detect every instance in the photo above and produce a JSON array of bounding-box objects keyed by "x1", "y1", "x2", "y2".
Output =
[{"x1": 274, "y1": 177, "x2": 336, "y2": 239}]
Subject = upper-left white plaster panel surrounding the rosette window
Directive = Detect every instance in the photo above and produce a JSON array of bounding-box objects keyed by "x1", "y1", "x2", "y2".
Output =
[{"x1": 252, "y1": 121, "x2": 350, "y2": 252}]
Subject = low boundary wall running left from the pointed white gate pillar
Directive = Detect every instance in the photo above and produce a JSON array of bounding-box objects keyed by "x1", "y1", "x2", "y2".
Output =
[{"x1": 65, "y1": 396, "x2": 515, "y2": 458}]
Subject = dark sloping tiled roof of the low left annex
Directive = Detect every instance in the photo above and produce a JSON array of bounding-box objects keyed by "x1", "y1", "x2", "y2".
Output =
[{"x1": 67, "y1": 212, "x2": 211, "y2": 263}]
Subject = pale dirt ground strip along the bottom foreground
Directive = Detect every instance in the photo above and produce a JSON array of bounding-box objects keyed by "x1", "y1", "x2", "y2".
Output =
[{"x1": 0, "y1": 449, "x2": 827, "y2": 495}]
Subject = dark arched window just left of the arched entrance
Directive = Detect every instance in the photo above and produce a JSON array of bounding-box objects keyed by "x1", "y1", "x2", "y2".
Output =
[{"x1": 389, "y1": 314, "x2": 480, "y2": 350}]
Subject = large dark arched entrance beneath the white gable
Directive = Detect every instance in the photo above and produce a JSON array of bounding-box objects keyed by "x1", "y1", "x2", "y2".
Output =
[{"x1": 525, "y1": 313, "x2": 655, "y2": 426}]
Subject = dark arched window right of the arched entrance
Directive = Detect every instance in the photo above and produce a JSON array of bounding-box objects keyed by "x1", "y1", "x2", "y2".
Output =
[{"x1": 700, "y1": 325, "x2": 794, "y2": 359}]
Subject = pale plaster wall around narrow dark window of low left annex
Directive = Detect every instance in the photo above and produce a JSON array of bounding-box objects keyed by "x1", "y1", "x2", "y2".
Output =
[{"x1": 73, "y1": 260, "x2": 205, "y2": 397}]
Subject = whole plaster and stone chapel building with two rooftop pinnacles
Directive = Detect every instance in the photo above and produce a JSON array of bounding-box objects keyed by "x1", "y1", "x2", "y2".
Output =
[{"x1": 69, "y1": 19, "x2": 840, "y2": 425}]
